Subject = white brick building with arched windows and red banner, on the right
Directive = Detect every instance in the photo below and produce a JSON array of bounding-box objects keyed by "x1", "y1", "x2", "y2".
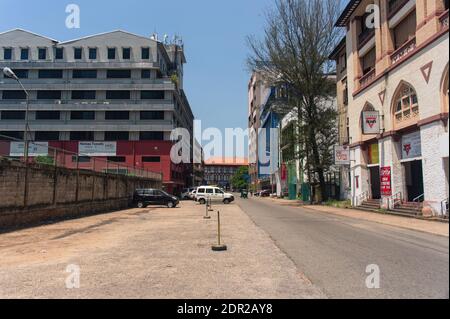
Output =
[{"x1": 336, "y1": 0, "x2": 449, "y2": 215}]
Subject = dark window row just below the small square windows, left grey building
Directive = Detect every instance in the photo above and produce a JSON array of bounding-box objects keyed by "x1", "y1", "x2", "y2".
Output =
[{"x1": 3, "y1": 69, "x2": 156, "y2": 79}]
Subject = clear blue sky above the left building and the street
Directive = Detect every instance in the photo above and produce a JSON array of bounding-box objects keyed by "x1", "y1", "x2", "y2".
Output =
[{"x1": 0, "y1": 0, "x2": 273, "y2": 156}]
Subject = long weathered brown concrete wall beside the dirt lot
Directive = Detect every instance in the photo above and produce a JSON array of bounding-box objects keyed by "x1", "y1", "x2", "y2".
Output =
[{"x1": 0, "y1": 159, "x2": 161, "y2": 229}]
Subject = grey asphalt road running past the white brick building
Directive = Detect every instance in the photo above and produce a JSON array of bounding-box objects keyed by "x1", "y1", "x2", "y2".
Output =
[{"x1": 237, "y1": 199, "x2": 449, "y2": 298}]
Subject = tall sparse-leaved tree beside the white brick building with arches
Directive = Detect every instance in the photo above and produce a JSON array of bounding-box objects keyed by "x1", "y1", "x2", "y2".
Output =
[{"x1": 247, "y1": 0, "x2": 341, "y2": 200}]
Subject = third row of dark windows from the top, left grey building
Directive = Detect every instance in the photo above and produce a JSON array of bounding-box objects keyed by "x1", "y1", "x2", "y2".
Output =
[{"x1": 2, "y1": 90, "x2": 165, "y2": 100}]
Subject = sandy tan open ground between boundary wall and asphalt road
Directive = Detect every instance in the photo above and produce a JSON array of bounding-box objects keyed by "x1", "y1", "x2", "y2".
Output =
[{"x1": 0, "y1": 202, "x2": 326, "y2": 298}]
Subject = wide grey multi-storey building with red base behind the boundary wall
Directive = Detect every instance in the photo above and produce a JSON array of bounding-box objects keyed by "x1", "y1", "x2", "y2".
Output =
[{"x1": 0, "y1": 29, "x2": 193, "y2": 192}]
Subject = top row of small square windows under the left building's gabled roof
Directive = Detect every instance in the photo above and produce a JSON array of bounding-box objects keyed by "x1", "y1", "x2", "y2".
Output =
[{"x1": 3, "y1": 48, "x2": 150, "y2": 61}]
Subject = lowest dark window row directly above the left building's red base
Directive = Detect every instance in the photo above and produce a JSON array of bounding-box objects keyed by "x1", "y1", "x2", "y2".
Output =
[{"x1": 0, "y1": 131, "x2": 164, "y2": 142}]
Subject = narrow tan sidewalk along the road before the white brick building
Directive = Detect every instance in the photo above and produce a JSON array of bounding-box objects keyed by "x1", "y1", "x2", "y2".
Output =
[{"x1": 260, "y1": 198, "x2": 449, "y2": 237}]
